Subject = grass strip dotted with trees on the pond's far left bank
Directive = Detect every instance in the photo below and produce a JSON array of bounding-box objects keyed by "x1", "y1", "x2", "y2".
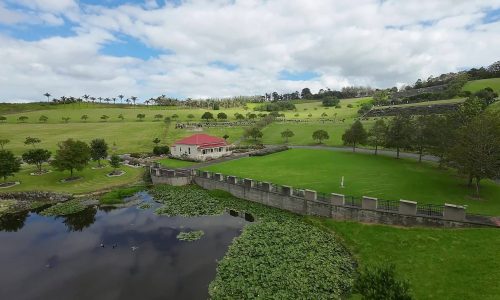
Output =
[{"x1": 0, "y1": 163, "x2": 144, "y2": 194}]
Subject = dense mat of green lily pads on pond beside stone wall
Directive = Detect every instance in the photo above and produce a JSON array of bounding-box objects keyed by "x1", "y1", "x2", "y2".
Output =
[{"x1": 152, "y1": 186, "x2": 353, "y2": 299}]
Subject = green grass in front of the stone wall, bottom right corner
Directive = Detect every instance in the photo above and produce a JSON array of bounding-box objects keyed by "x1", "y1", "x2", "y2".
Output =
[{"x1": 308, "y1": 217, "x2": 500, "y2": 300}]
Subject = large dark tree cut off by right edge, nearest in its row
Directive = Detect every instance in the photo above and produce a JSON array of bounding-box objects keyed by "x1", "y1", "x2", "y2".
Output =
[{"x1": 450, "y1": 112, "x2": 500, "y2": 196}]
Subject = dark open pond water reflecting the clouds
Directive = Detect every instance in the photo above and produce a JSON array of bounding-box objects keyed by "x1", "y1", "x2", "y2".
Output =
[{"x1": 0, "y1": 193, "x2": 245, "y2": 300}]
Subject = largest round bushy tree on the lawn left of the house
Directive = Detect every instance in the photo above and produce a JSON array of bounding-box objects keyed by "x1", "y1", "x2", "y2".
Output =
[{"x1": 52, "y1": 139, "x2": 91, "y2": 177}]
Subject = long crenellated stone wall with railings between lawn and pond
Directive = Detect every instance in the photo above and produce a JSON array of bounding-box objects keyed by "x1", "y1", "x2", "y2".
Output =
[{"x1": 151, "y1": 168, "x2": 495, "y2": 227}]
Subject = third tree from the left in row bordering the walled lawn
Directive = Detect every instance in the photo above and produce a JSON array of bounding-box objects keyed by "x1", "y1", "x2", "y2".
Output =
[{"x1": 386, "y1": 115, "x2": 413, "y2": 158}]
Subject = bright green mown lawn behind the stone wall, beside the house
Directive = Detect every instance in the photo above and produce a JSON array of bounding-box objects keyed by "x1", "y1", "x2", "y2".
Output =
[{"x1": 204, "y1": 149, "x2": 500, "y2": 215}]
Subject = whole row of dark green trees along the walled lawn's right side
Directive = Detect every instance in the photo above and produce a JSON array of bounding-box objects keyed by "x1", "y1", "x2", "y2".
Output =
[{"x1": 342, "y1": 97, "x2": 500, "y2": 195}]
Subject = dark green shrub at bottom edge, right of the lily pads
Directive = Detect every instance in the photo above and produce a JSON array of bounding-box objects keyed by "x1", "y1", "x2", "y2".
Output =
[{"x1": 354, "y1": 265, "x2": 412, "y2": 300}]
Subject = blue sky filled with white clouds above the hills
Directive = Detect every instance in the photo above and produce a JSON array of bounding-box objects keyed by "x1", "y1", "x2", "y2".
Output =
[{"x1": 0, "y1": 0, "x2": 500, "y2": 102}]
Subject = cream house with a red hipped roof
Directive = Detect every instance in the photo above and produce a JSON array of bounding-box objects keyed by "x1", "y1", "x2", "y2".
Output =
[{"x1": 170, "y1": 134, "x2": 231, "y2": 161}]
